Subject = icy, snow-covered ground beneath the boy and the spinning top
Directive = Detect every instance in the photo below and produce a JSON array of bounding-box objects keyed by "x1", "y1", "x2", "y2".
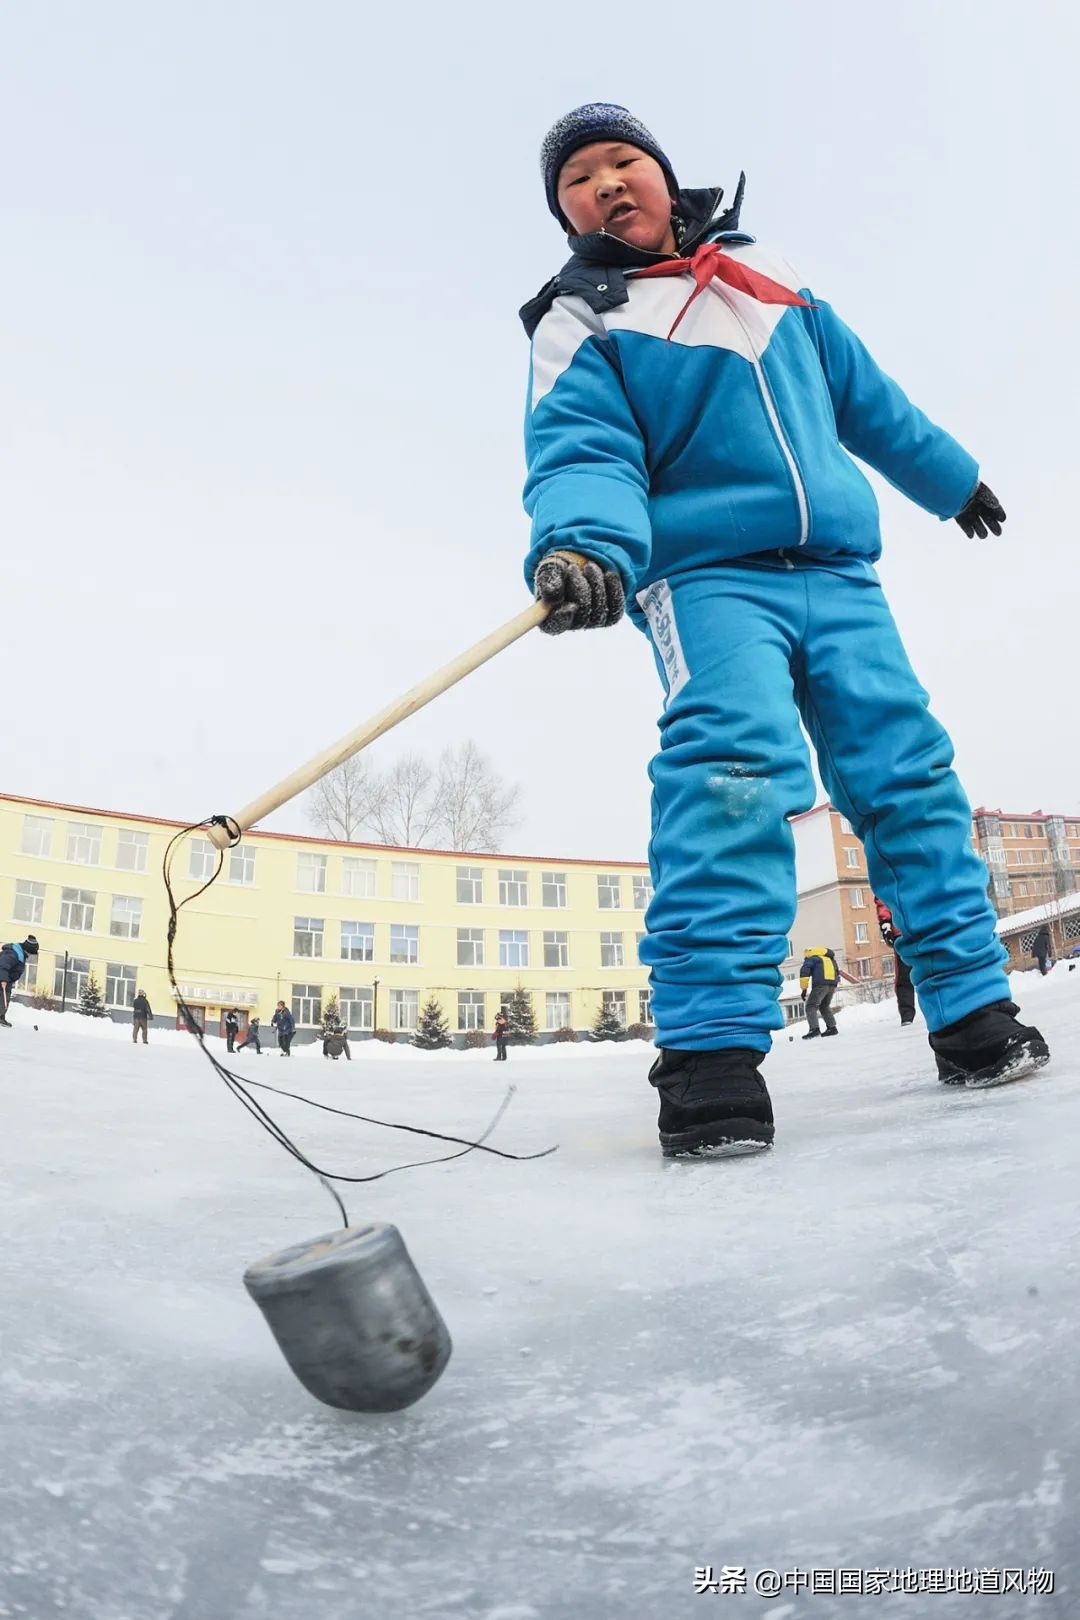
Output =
[{"x1": 0, "y1": 964, "x2": 1080, "y2": 1620}]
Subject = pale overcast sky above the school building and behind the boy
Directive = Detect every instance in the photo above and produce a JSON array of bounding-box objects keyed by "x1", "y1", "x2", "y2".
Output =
[{"x1": 0, "y1": 0, "x2": 1080, "y2": 859}]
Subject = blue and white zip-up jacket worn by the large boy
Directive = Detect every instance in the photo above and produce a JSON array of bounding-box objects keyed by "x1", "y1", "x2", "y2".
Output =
[{"x1": 521, "y1": 183, "x2": 978, "y2": 595}]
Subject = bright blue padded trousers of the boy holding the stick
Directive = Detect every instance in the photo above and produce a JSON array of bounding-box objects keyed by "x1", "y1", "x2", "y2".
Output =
[{"x1": 633, "y1": 559, "x2": 1009, "y2": 1051}]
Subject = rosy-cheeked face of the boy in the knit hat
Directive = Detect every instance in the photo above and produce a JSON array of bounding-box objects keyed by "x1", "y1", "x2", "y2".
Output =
[{"x1": 559, "y1": 141, "x2": 675, "y2": 253}]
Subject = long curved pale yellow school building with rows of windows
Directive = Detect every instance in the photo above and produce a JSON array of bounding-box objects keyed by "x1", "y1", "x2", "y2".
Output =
[{"x1": 0, "y1": 794, "x2": 651, "y2": 1040}]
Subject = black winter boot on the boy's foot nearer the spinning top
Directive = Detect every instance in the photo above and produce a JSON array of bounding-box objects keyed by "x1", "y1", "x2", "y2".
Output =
[{"x1": 649, "y1": 1047, "x2": 772, "y2": 1158}]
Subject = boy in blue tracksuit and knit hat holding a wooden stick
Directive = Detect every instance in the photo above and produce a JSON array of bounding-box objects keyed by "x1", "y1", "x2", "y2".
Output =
[{"x1": 521, "y1": 102, "x2": 1049, "y2": 1157}]
